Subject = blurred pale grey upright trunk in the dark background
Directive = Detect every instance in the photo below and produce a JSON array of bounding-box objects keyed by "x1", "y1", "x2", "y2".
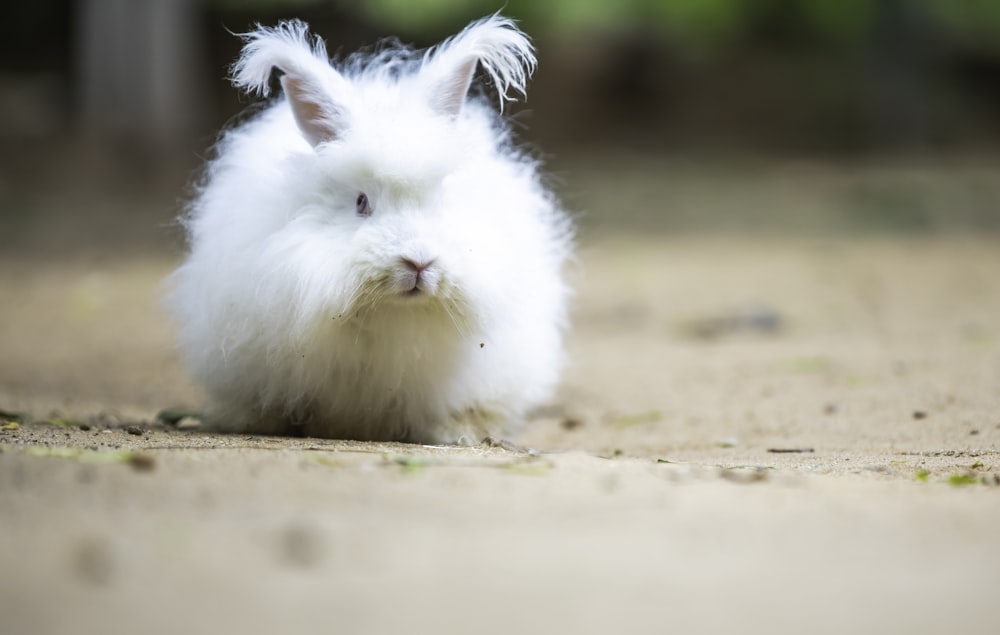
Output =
[{"x1": 76, "y1": 0, "x2": 207, "y2": 158}]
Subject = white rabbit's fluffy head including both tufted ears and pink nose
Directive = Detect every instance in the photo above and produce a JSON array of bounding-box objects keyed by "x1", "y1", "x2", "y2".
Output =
[{"x1": 220, "y1": 16, "x2": 547, "y2": 330}]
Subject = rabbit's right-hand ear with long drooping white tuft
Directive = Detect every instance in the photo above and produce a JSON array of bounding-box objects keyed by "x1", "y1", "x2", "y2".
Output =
[{"x1": 420, "y1": 14, "x2": 537, "y2": 116}]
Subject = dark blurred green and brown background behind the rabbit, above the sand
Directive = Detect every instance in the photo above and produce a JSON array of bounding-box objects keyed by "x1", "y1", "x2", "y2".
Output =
[{"x1": 0, "y1": 0, "x2": 1000, "y2": 253}]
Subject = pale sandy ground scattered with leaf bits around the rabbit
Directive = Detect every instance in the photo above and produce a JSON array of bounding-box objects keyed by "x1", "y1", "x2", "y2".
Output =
[{"x1": 0, "y1": 235, "x2": 1000, "y2": 634}]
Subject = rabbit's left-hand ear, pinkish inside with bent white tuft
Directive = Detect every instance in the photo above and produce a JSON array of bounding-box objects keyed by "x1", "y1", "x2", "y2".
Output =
[{"x1": 232, "y1": 20, "x2": 348, "y2": 146}]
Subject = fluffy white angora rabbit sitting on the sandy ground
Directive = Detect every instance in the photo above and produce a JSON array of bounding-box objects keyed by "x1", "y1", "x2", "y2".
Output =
[{"x1": 168, "y1": 15, "x2": 572, "y2": 444}]
